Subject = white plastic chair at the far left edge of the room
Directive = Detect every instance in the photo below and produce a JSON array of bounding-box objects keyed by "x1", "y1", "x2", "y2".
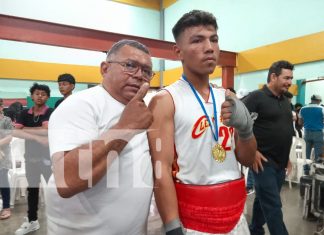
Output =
[{"x1": 8, "y1": 137, "x2": 28, "y2": 207}]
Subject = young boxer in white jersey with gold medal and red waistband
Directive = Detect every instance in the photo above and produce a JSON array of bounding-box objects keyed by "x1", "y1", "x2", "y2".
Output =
[{"x1": 149, "y1": 10, "x2": 256, "y2": 235}]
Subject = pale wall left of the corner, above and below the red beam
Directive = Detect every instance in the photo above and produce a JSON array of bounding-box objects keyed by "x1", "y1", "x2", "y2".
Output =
[{"x1": 0, "y1": 0, "x2": 160, "y2": 98}]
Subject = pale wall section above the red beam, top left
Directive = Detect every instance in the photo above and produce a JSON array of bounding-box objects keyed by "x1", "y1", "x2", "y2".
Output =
[{"x1": 0, "y1": 0, "x2": 160, "y2": 39}]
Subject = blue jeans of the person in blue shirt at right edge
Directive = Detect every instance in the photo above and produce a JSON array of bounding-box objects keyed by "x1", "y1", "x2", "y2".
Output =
[{"x1": 304, "y1": 130, "x2": 324, "y2": 161}]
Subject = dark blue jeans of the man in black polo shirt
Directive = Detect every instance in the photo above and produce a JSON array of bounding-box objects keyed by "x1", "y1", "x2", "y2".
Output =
[{"x1": 250, "y1": 163, "x2": 288, "y2": 235}]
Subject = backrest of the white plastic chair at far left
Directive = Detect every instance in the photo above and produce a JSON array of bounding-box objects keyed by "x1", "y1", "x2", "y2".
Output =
[{"x1": 10, "y1": 137, "x2": 25, "y2": 170}]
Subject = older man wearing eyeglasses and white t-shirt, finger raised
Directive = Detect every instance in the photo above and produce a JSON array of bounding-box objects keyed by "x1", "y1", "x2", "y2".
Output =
[{"x1": 47, "y1": 40, "x2": 154, "y2": 235}]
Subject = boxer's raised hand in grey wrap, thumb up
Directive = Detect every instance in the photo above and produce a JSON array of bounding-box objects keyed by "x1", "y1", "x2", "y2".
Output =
[{"x1": 221, "y1": 90, "x2": 253, "y2": 139}]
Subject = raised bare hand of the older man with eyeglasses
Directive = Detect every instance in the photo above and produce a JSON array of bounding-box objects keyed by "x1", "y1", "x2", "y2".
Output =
[{"x1": 116, "y1": 83, "x2": 153, "y2": 130}]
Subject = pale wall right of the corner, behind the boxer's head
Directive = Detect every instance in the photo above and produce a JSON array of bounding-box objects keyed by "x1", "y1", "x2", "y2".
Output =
[{"x1": 165, "y1": 0, "x2": 324, "y2": 102}]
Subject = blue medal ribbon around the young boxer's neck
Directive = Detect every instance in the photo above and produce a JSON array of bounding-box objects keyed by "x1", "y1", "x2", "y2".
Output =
[{"x1": 182, "y1": 74, "x2": 218, "y2": 142}]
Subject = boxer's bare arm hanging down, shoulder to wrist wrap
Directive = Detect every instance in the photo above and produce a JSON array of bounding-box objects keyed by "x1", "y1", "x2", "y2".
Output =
[{"x1": 148, "y1": 91, "x2": 179, "y2": 228}]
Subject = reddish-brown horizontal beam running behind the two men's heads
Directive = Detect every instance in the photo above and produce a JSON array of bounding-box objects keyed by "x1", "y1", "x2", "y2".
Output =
[{"x1": 0, "y1": 14, "x2": 236, "y2": 67}]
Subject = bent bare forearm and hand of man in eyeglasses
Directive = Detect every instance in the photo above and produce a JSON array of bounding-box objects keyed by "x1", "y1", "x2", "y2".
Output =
[{"x1": 50, "y1": 84, "x2": 152, "y2": 198}]
